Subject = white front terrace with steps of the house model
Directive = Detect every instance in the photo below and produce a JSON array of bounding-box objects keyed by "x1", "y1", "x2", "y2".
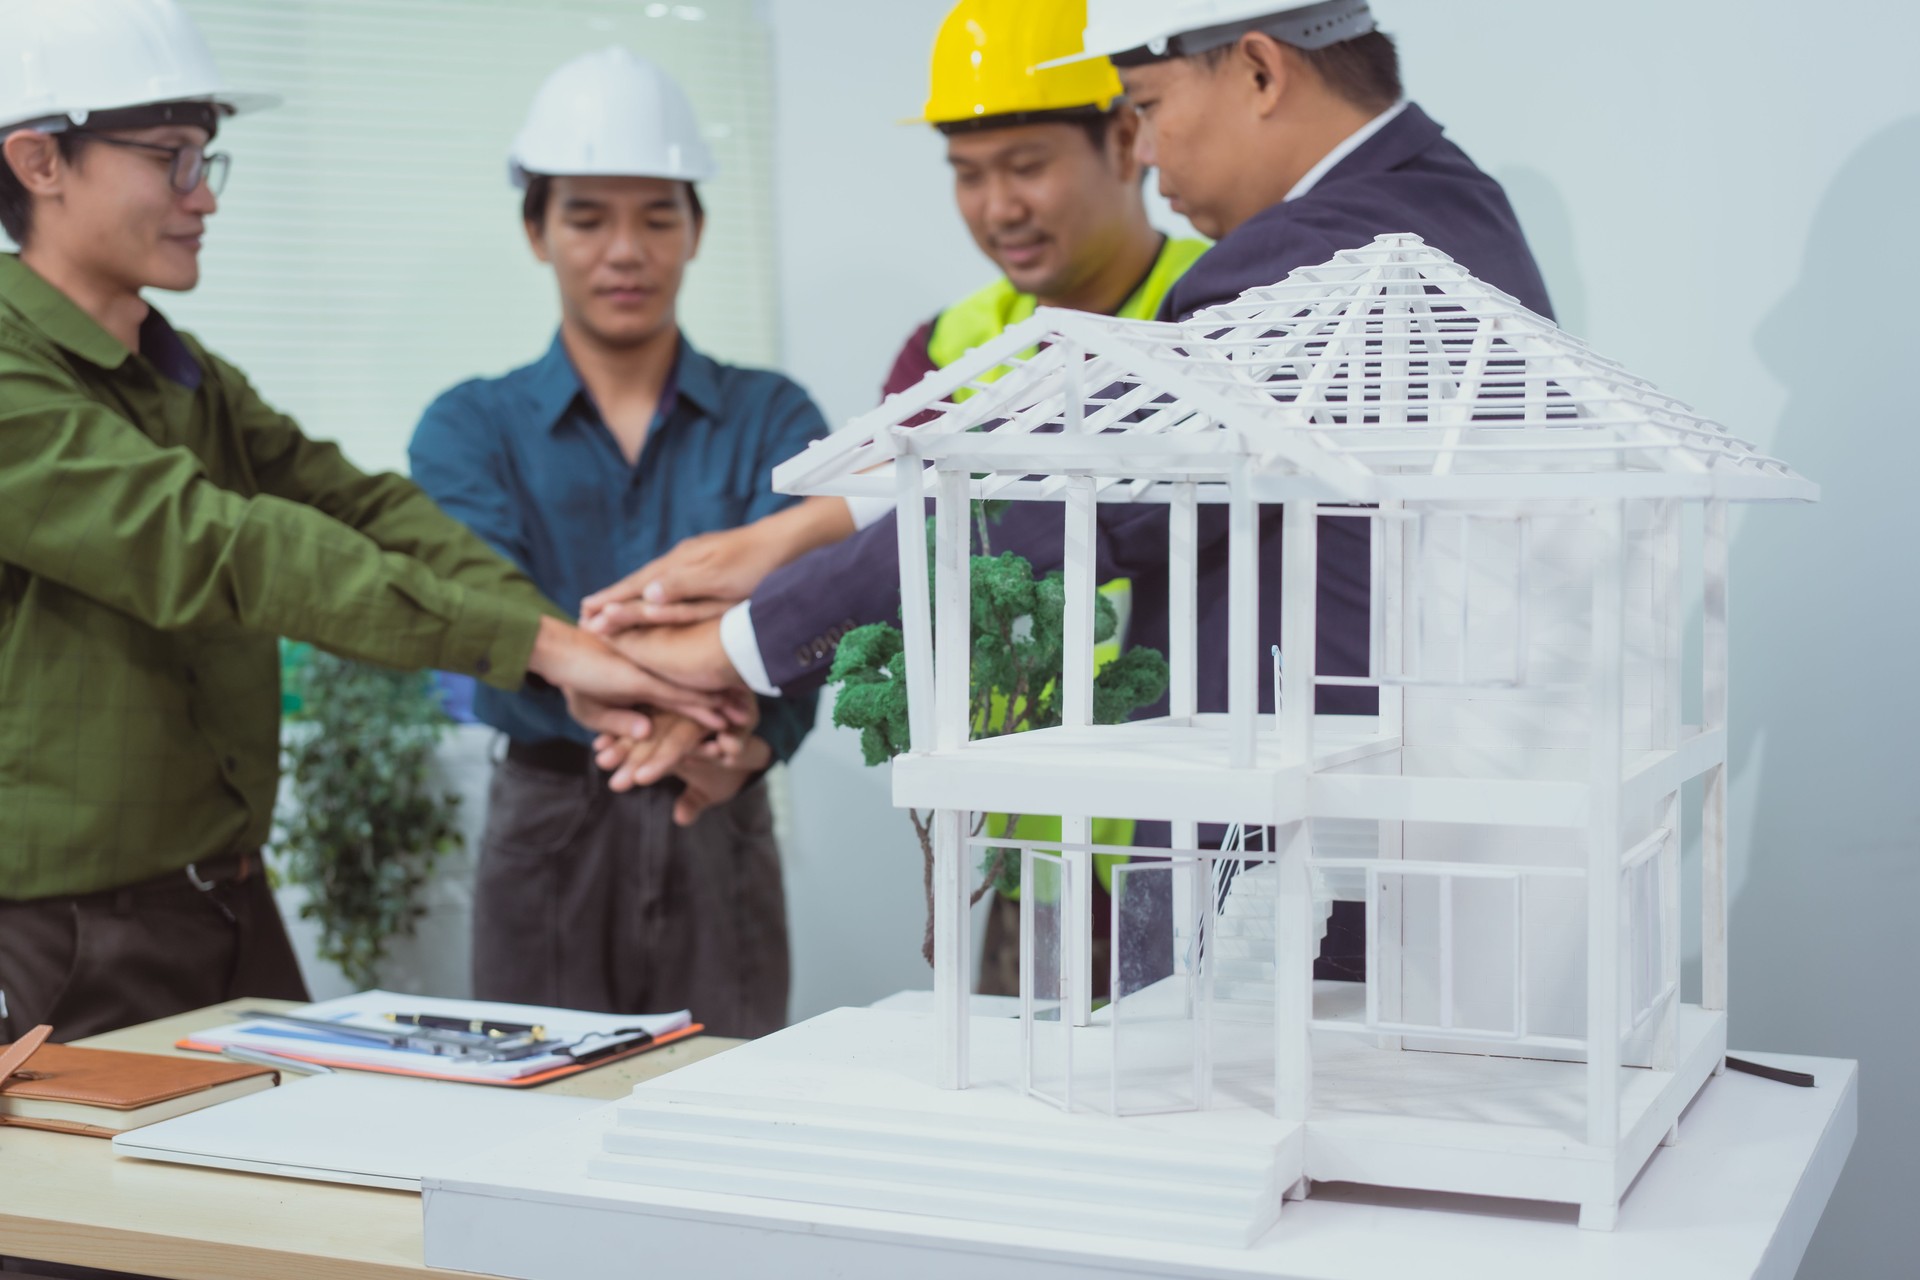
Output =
[{"x1": 588, "y1": 1009, "x2": 1302, "y2": 1247}]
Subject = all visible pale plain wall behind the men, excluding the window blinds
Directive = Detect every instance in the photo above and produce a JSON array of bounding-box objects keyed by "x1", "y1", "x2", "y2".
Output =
[{"x1": 768, "y1": 0, "x2": 1920, "y2": 1280}]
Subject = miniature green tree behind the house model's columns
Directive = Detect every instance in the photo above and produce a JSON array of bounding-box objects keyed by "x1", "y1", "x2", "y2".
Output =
[{"x1": 828, "y1": 545, "x2": 1167, "y2": 963}]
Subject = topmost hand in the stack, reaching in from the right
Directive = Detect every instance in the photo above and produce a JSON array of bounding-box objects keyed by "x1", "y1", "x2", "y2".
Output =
[{"x1": 580, "y1": 497, "x2": 852, "y2": 635}]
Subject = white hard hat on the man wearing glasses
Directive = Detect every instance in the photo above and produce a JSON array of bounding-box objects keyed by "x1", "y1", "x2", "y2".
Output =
[{"x1": 0, "y1": 0, "x2": 280, "y2": 130}]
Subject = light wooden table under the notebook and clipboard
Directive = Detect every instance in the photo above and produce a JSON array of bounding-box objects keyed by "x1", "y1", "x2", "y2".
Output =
[{"x1": 0, "y1": 1000, "x2": 739, "y2": 1280}]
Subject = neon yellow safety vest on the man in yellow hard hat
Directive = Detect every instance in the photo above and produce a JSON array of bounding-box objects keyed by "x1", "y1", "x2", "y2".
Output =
[{"x1": 927, "y1": 236, "x2": 1212, "y2": 890}]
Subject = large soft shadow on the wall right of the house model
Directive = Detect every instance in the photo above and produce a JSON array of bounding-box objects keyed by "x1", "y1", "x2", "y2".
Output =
[{"x1": 1732, "y1": 117, "x2": 1920, "y2": 1280}]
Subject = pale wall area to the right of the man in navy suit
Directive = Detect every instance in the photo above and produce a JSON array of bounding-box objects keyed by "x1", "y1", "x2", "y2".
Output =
[{"x1": 1382, "y1": 0, "x2": 1920, "y2": 1280}]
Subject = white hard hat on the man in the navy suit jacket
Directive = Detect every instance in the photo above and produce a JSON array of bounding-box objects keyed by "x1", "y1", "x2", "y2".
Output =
[{"x1": 1081, "y1": 0, "x2": 1373, "y2": 65}]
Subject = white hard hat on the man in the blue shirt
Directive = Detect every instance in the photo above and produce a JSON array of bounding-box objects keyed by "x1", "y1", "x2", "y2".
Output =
[{"x1": 507, "y1": 48, "x2": 714, "y2": 186}]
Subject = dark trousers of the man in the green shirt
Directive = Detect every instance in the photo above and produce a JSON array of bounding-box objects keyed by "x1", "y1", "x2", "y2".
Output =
[{"x1": 0, "y1": 854, "x2": 307, "y2": 1042}]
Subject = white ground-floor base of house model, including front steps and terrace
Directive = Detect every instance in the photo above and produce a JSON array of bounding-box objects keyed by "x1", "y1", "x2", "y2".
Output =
[{"x1": 428, "y1": 986, "x2": 1766, "y2": 1274}]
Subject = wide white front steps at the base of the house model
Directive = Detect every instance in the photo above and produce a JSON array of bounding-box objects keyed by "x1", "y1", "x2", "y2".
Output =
[{"x1": 588, "y1": 1088, "x2": 1284, "y2": 1247}]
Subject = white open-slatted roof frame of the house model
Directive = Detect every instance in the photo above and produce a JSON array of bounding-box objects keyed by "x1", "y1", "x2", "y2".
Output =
[{"x1": 774, "y1": 236, "x2": 1818, "y2": 501}]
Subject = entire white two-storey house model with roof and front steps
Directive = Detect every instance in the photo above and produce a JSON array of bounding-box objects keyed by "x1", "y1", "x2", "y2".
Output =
[{"x1": 416, "y1": 236, "x2": 1816, "y2": 1266}]
